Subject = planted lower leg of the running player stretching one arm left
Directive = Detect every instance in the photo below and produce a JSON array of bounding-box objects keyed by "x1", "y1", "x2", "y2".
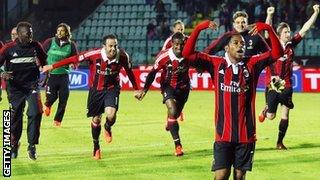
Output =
[{"x1": 91, "y1": 115, "x2": 101, "y2": 160}]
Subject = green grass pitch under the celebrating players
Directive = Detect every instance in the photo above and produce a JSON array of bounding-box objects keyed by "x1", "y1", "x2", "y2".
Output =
[{"x1": 0, "y1": 91, "x2": 320, "y2": 180}]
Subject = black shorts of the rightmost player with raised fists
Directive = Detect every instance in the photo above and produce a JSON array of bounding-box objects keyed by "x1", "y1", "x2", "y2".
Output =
[{"x1": 267, "y1": 88, "x2": 294, "y2": 113}]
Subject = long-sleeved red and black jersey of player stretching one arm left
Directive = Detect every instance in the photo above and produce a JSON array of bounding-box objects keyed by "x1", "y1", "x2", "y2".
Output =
[{"x1": 52, "y1": 48, "x2": 138, "y2": 90}]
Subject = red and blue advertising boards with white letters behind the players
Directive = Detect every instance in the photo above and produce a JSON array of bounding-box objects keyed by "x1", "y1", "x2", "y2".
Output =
[{"x1": 2, "y1": 66, "x2": 320, "y2": 92}]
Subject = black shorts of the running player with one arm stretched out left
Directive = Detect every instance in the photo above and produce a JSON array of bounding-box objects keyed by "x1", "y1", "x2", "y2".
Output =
[{"x1": 87, "y1": 87, "x2": 120, "y2": 117}]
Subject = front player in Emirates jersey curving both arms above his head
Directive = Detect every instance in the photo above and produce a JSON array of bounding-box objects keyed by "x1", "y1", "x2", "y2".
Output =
[{"x1": 183, "y1": 21, "x2": 283, "y2": 179}]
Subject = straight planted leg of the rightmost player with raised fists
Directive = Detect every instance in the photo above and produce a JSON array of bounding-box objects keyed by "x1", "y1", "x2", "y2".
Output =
[{"x1": 277, "y1": 105, "x2": 290, "y2": 150}]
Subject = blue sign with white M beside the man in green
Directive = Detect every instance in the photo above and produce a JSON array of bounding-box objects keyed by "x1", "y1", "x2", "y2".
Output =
[{"x1": 69, "y1": 71, "x2": 88, "y2": 89}]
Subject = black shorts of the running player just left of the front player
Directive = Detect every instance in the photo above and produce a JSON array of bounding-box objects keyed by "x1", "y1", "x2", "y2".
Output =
[{"x1": 161, "y1": 85, "x2": 190, "y2": 104}]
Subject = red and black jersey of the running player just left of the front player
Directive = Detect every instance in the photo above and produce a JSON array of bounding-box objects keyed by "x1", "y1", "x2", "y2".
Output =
[{"x1": 152, "y1": 48, "x2": 190, "y2": 88}]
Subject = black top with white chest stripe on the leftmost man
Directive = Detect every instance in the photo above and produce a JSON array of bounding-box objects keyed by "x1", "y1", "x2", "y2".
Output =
[{"x1": 0, "y1": 40, "x2": 47, "y2": 90}]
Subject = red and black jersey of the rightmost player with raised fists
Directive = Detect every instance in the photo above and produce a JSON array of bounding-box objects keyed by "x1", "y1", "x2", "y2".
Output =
[{"x1": 265, "y1": 33, "x2": 302, "y2": 88}]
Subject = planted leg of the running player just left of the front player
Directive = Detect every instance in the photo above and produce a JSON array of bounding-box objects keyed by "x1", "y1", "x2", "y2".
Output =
[{"x1": 165, "y1": 98, "x2": 183, "y2": 156}]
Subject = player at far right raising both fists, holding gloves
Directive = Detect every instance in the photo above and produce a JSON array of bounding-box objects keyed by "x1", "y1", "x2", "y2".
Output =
[{"x1": 259, "y1": 4, "x2": 319, "y2": 150}]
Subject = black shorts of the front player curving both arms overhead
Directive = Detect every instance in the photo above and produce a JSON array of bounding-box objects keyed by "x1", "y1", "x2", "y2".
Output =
[{"x1": 211, "y1": 142, "x2": 255, "y2": 171}]
